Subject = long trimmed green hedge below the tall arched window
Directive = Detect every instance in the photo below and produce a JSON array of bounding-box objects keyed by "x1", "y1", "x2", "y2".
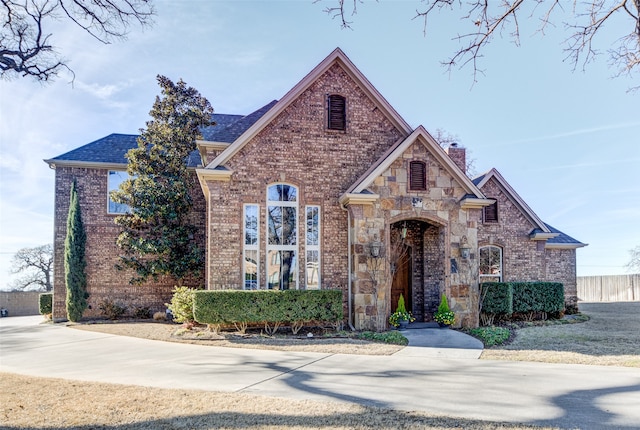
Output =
[{"x1": 193, "y1": 290, "x2": 343, "y2": 325}]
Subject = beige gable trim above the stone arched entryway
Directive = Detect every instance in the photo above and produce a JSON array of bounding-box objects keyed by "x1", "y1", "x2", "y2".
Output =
[{"x1": 341, "y1": 126, "x2": 491, "y2": 207}]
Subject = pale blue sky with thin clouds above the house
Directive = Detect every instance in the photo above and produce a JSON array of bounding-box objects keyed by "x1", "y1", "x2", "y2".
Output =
[{"x1": 0, "y1": 0, "x2": 640, "y2": 289}]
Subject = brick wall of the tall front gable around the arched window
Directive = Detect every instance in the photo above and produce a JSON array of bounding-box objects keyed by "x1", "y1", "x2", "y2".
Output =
[{"x1": 208, "y1": 65, "x2": 401, "y2": 299}]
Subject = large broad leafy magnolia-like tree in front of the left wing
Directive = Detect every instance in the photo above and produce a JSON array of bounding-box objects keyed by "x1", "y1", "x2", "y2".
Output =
[{"x1": 111, "y1": 76, "x2": 214, "y2": 284}]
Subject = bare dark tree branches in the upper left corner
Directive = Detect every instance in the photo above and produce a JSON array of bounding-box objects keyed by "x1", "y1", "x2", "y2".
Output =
[{"x1": 0, "y1": 0, "x2": 154, "y2": 81}]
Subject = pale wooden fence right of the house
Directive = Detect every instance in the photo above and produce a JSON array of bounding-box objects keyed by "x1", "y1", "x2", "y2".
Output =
[{"x1": 577, "y1": 274, "x2": 640, "y2": 302}]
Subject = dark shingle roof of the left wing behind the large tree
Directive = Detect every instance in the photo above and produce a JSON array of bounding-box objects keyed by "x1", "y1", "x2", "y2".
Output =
[{"x1": 48, "y1": 100, "x2": 277, "y2": 167}]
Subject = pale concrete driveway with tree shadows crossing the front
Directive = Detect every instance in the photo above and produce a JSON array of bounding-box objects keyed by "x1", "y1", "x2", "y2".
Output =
[{"x1": 0, "y1": 317, "x2": 640, "y2": 429}]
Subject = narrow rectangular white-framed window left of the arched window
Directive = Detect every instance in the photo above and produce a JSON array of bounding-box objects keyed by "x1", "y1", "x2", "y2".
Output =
[{"x1": 242, "y1": 204, "x2": 260, "y2": 290}]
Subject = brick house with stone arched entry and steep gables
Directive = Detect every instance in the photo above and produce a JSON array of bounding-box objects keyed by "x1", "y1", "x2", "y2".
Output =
[{"x1": 46, "y1": 49, "x2": 585, "y2": 329}]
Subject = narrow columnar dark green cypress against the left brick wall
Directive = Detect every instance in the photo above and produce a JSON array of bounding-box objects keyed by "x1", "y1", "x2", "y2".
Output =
[{"x1": 64, "y1": 181, "x2": 88, "y2": 322}]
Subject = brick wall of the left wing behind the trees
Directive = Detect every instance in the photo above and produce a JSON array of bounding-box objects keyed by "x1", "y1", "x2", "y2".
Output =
[{"x1": 53, "y1": 166, "x2": 206, "y2": 320}]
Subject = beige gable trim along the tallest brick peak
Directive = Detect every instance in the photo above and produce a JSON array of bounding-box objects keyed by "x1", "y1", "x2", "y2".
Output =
[{"x1": 206, "y1": 48, "x2": 411, "y2": 169}]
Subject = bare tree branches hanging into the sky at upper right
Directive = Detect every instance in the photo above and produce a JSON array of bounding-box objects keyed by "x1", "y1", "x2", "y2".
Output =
[{"x1": 316, "y1": 0, "x2": 640, "y2": 89}]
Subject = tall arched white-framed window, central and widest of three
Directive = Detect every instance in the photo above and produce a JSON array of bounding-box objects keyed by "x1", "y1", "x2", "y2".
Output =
[{"x1": 266, "y1": 184, "x2": 298, "y2": 290}]
